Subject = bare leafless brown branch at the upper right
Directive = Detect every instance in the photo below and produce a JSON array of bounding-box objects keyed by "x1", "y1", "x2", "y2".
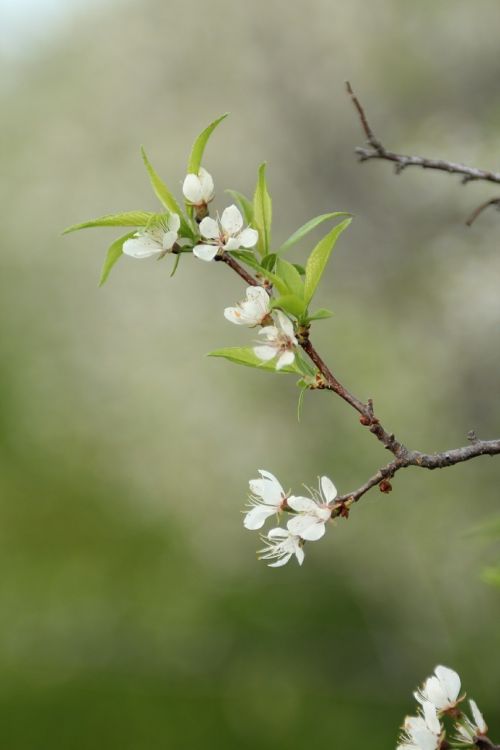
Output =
[{"x1": 346, "y1": 81, "x2": 500, "y2": 227}]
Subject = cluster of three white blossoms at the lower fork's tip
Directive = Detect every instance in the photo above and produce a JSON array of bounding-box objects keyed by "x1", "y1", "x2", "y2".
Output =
[{"x1": 243, "y1": 469, "x2": 337, "y2": 568}]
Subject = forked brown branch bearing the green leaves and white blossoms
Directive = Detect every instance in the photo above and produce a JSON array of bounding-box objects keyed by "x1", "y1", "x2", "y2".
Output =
[{"x1": 220, "y1": 253, "x2": 500, "y2": 508}]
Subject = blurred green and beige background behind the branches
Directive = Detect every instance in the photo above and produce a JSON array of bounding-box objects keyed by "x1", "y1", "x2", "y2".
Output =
[{"x1": 0, "y1": 0, "x2": 500, "y2": 750}]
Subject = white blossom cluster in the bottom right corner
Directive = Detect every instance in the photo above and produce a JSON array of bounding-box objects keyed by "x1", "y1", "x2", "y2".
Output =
[{"x1": 397, "y1": 666, "x2": 488, "y2": 750}]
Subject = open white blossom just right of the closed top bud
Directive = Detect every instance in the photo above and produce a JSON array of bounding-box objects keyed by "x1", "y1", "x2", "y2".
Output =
[{"x1": 193, "y1": 204, "x2": 259, "y2": 260}]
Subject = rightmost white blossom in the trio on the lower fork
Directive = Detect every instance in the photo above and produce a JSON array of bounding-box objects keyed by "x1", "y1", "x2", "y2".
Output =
[{"x1": 286, "y1": 477, "x2": 337, "y2": 542}]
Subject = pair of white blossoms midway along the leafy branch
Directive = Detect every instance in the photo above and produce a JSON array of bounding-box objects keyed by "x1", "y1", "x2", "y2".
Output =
[{"x1": 226, "y1": 288, "x2": 298, "y2": 370}]
